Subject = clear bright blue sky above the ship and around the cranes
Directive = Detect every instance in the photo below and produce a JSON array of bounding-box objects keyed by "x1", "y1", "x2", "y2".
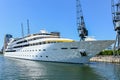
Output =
[{"x1": 0, "y1": 0, "x2": 115, "y2": 48}]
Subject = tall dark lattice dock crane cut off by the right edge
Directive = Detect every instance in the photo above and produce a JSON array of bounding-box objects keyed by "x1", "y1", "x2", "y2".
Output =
[{"x1": 111, "y1": 0, "x2": 120, "y2": 55}]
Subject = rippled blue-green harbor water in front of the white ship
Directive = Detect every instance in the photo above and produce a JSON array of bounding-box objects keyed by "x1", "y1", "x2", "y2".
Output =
[{"x1": 0, "y1": 55, "x2": 120, "y2": 80}]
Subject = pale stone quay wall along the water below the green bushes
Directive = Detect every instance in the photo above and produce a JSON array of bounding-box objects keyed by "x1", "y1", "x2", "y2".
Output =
[{"x1": 90, "y1": 56, "x2": 120, "y2": 63}]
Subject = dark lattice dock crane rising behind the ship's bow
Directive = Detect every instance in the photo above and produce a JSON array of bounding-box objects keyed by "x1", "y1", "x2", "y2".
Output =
[{"x1": 76, "y1": 0, "x2": 88, "y2": 41}]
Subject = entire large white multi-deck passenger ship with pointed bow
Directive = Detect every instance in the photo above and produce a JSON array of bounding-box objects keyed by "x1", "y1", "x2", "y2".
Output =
[{"x1": 4, "y1": 30, "x2": 114, "y2": 63}]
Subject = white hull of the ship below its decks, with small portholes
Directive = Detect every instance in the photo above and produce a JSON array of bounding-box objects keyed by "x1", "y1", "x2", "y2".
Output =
[{"x1": 4, "y1": 41, "x2": 114, "y2": 63}]
